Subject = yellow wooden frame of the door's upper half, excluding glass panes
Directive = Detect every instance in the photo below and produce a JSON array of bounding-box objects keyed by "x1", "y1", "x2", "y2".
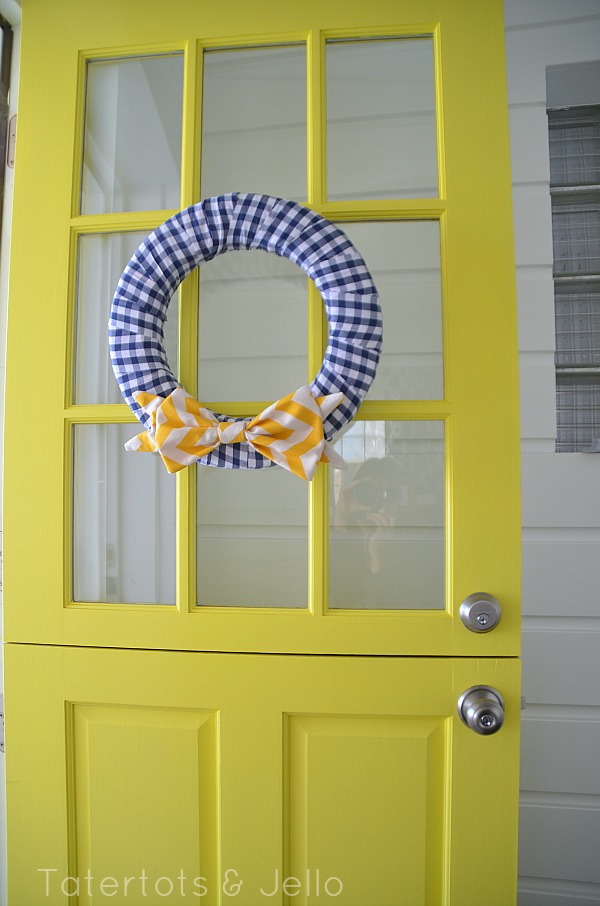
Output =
[{"x1": 5, "y1": 0, "x2": 520, "y2": 657}]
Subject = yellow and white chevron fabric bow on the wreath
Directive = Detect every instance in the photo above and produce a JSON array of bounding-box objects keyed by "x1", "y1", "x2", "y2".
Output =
[{"x1": 125, "y1": 386, "x2": 346, "y2": 481}]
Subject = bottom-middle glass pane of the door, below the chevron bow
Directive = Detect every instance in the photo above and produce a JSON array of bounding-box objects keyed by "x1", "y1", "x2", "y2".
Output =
[{"x1": 197, "y1": 467, "x2": 308, "y2": 607}]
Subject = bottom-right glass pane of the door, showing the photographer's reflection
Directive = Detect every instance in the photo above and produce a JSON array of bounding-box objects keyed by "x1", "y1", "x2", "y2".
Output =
[{"x1": 329, "y1": 421, "x2": 445, "y2": 610}]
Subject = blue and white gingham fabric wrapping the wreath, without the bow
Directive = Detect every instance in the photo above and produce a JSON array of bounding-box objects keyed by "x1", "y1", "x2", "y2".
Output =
[{"x1": 108, "y1": 192, "x2": 382, "y2": 469}]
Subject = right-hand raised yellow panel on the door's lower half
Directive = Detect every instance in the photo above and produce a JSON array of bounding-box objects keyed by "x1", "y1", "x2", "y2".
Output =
[{"x1": 287, "y1": 714, "x2": 449, "y2": 906}]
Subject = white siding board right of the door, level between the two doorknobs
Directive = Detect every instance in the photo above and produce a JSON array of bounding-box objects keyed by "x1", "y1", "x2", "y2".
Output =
[{"x1": 523, "y1": 628, "x2": 600, "y2": 708}]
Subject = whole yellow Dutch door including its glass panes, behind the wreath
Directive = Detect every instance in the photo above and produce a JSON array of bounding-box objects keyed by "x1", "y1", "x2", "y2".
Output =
[{"x1": 4, "y1": 0, "x2": 520, "y2": 906}]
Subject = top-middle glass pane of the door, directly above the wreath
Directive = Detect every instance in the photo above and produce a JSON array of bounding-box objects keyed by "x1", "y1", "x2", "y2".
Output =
[{"x1": 202, "y1": 45, "x2": 306, "y2": 201}]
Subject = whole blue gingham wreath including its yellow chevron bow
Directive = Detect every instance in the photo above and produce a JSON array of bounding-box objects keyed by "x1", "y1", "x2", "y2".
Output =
[{"x1": 109, "y1": 193, "x2": 382, "y2": 480}]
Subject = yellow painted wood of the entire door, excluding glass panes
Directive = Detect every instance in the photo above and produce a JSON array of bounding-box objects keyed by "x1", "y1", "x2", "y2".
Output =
[{"x1": 4, "y1": 0, "x2": 520, "y2": 906}]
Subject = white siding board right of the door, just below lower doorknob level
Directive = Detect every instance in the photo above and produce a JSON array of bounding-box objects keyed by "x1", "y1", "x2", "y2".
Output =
[{"x1": 521, "y1": 709, "x2": 600, "y2": 795}]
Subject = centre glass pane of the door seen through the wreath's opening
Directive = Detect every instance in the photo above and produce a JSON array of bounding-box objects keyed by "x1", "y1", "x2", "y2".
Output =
[{"x1": 198, "y1": 250, "x2": 308, "y2": 401}]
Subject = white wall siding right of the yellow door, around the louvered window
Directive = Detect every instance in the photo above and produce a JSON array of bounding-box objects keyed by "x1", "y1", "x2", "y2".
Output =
[{"x1": 505, "y1": 0, "x2": 600, "y2": 906}]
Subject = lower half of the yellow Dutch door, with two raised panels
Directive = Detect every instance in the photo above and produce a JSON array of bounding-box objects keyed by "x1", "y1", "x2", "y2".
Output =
[{"x1": 6, "y1": 645, "x2": 519, "y2": 906}]
